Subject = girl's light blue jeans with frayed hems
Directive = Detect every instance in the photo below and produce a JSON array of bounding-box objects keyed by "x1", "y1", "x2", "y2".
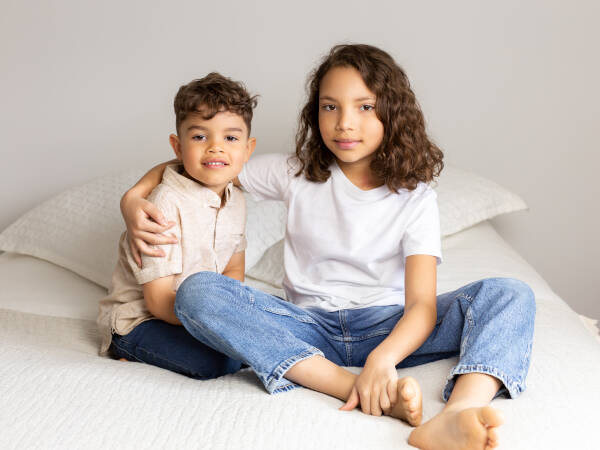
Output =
[{"x1": 175, "y1": 272, "x2": 535, "y2": 400}]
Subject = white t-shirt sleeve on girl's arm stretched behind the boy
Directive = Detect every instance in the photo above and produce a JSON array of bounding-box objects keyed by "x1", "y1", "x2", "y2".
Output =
[{"x1": 238, "y1": 153, "x2": 295, "y2": 200}]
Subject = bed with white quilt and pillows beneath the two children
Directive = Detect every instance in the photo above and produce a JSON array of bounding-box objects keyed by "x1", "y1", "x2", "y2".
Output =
[{"x1": 0, "y1": 163, "x2": 600, "y2": 450}]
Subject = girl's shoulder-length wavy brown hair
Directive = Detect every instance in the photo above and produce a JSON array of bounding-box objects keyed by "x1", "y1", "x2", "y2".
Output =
[{"x1": 296, "y1": 44, "x2": 444, "y2": 192}]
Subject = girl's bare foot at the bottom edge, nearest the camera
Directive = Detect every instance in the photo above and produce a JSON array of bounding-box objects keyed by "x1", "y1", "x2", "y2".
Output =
[{"x1": 408, "y1": 406, "x2": 503, "y2": 450}]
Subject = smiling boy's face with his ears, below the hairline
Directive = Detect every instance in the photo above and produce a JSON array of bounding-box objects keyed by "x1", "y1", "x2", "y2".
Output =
[{"x1": 169, "y1": 111, "x2": 256, "y2": 196}]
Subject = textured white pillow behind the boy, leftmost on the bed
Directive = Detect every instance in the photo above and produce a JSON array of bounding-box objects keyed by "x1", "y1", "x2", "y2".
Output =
[{"x1": 0, "y1": 170, "x2": 286, "y2": 287}]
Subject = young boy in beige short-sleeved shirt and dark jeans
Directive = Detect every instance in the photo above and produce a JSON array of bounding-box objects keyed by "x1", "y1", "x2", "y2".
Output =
[{"x1": 98, "y1": 73, "x2": 256, "y2": 379}]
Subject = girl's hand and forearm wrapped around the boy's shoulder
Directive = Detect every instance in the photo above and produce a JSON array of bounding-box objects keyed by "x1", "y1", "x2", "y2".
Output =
[{"x1": 121, "y1": 160, "x2": 177, "y2": 267}]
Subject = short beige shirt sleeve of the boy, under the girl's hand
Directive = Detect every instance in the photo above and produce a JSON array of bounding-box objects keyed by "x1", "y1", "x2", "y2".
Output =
[{"x1": 127, "y1": 191, "x2": 183, "y2": 284}]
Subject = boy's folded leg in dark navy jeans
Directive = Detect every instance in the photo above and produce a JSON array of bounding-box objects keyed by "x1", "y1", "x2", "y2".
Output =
[{"x1": 110, "y1": 319, "x2": 242, "y2": 380}]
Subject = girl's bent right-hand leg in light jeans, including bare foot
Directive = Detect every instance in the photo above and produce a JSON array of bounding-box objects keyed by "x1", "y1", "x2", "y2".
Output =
[{"x1": 401, "y1": 278, "x2": 535, "y2": 449}]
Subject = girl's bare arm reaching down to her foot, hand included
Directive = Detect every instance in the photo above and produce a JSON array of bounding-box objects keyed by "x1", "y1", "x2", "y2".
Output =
[{"x1": 340, "y1": 255, "x2": 437, "y2": 415}]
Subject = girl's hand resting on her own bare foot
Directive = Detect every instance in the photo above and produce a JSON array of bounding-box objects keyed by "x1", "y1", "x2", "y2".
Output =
[{"x1": 340, "y1": 351, "x2": 398, "y2": 416}]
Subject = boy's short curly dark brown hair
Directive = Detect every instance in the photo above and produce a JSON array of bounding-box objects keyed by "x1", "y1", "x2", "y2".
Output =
[{"x1": 174, "y1": 72, "x2": 257, "y2": 135}]
